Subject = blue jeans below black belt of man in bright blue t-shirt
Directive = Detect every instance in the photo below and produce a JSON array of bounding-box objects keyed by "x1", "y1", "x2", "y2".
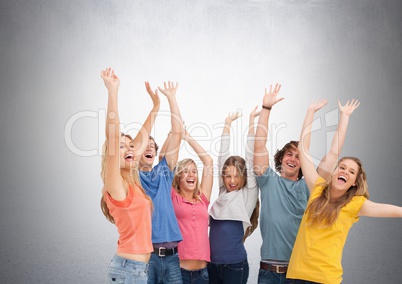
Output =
[{"x1": 148, "y1": 253, "x2": 183, "y2": 284}]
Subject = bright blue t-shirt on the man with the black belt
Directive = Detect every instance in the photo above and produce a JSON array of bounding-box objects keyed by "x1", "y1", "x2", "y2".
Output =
[{"x1": 140, "y1": 158, "x2": 183, "y2": 244}]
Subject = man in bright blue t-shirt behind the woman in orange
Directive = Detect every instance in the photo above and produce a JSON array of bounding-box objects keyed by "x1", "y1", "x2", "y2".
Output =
[{"x1": 139, "y1": 82, "x2": 183, "y2": 284}]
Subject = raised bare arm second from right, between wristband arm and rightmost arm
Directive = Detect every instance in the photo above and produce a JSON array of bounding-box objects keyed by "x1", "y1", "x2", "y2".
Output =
[{"x1": 298, "y1": 100, "x2": 327, "y2": 191}]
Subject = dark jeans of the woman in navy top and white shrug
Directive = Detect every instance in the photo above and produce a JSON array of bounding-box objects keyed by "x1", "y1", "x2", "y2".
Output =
[{"x1": 208, "y1": 259, "x2": 249, "y2": 284}]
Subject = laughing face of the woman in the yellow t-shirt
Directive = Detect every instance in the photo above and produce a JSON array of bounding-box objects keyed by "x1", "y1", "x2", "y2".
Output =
[{"x1": 331, "y1": 159, "x2": 359, "y2": 196}]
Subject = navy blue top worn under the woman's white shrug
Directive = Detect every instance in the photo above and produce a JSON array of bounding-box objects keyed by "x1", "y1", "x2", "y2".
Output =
[{"x1": 209, "y1": 217, "x2": 247, "y2": 264}]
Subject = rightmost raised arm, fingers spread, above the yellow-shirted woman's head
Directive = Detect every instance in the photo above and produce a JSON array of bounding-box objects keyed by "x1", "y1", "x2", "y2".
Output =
[{"x1": 317, "y1": 99, "x2": 360, "y2": 180}]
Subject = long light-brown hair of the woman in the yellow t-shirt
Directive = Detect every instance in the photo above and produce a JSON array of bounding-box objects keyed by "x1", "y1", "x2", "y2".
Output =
[{"x1": 306, "y1": 157, "x2": 369, "y2": 227}]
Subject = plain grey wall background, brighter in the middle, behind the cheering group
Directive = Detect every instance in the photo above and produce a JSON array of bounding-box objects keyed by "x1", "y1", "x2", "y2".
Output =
[{"x1": 0, "y1": 0, "x2": 402, "y2": 283}]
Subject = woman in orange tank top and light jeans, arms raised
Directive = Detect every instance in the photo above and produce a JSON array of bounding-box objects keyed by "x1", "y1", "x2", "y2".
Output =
[{"x1": 101, "y1": 68, "x2": 160, "y2": 284}]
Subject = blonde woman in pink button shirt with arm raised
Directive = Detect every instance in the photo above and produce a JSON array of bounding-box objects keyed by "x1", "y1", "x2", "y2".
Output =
[{"x1": 172, "y1": 131, "x2": 213, "y2": 284}]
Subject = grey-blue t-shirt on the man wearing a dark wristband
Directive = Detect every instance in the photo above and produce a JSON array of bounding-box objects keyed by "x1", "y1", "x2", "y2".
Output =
[{"x1": 257, "y1": 167, "x2": 310, "y2": 261}]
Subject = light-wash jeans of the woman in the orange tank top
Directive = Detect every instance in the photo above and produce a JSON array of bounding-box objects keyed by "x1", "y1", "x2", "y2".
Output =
[{"x1": 107, "y1": 255, "x2": 148, "y2": 284}]
